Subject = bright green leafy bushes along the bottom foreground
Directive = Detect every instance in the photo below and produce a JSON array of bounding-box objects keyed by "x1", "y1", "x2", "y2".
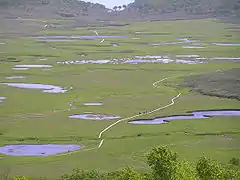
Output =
[{"x1": 7, "y1": 146, "x2": 240, "y2": 180}]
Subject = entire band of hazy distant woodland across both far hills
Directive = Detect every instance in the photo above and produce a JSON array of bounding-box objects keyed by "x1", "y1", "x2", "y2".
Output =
[{"x1": 0, "y1": 0, "x2": 240, "y2": 18}]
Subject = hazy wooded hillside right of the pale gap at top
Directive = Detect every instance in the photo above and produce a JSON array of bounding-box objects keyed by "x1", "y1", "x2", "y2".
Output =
[{"x1": 125, "y1": 0, "x2": 240, "y2": 17}]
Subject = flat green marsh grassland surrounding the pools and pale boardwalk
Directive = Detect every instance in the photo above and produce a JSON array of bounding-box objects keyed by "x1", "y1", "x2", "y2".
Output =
[{"x1": 0, "y1": 19, "x2": 240, "y2": 179}]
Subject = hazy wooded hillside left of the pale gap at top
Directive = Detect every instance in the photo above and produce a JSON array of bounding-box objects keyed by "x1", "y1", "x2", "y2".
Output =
[{"x1": 0, "y1": 0, "x2": 107, "y2": 18}]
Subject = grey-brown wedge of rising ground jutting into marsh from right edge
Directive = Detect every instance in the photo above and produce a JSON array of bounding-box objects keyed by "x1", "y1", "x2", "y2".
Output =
[{"x1": 185, "y1": 68, "x2": 240, "y2": 100}]
